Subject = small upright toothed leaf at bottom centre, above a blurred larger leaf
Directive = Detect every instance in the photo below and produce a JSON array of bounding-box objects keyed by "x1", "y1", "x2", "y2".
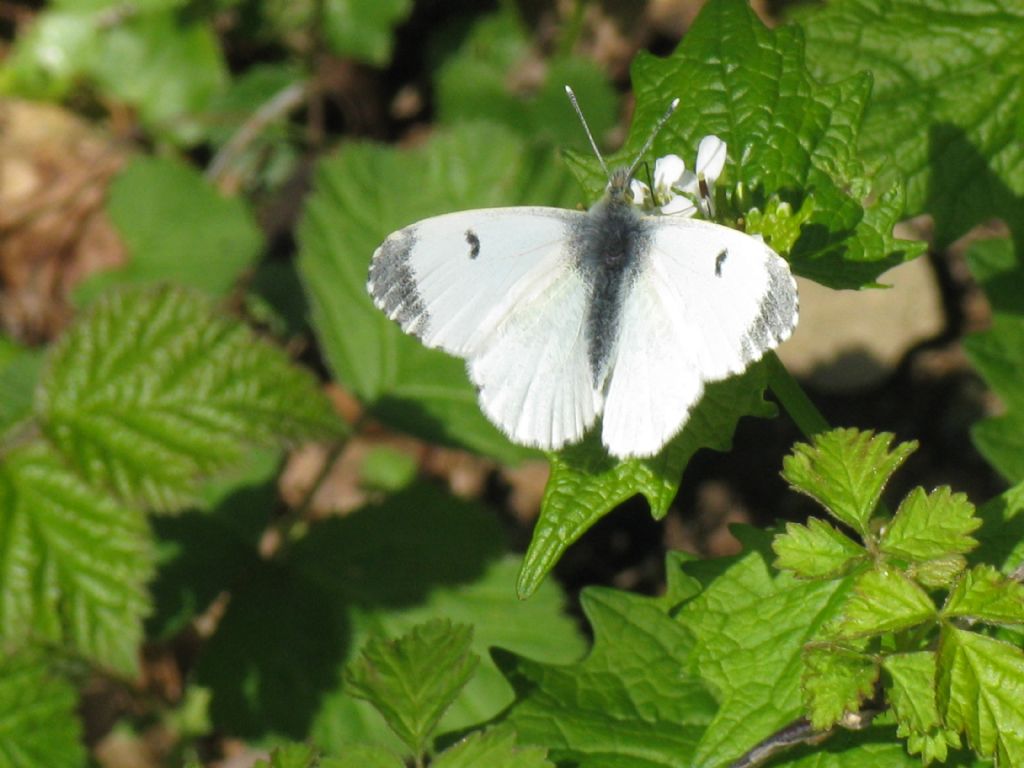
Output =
[{"x1": 345, "y1": 620, "x2": 480, "y2": 755}]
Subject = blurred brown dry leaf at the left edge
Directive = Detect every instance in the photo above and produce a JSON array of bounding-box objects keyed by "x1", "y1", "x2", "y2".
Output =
[{"x1": 0, "y1": 99, "x2": 129, "y2": 343}]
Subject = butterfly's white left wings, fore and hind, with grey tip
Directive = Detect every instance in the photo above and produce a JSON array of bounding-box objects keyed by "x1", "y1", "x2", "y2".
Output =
[{"x1": 368, "y1": 208, "x2": 601, "y2": 450}]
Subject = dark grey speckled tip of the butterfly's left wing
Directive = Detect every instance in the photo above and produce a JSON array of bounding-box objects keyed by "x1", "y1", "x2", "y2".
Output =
[{"x1": 367, "y1": 226, "x2": 430, "y2": 335}]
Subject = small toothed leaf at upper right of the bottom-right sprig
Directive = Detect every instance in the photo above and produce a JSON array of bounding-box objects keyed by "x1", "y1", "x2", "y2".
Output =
[{"x1": 879, "y1": 485, "x2": 981, "y2": 562}]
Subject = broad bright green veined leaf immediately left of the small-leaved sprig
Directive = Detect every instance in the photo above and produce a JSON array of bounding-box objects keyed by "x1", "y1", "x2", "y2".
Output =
[{"x1": 673, "y1": 534, "x2": 849, "y2": 768}]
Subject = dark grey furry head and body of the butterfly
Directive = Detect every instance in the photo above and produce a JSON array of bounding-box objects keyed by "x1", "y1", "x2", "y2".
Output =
[{"x1": 571, "y1": 171, "x2": 650, "y2": 390}]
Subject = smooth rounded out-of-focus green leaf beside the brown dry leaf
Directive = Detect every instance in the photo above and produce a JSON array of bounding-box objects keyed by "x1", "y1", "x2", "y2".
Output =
[{"x1": 76, "y1": 158, "x2": 263, "y2": 303}]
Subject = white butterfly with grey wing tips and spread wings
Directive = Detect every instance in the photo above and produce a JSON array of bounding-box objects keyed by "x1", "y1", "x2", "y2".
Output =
[{"x1": 368, "y1": 87, "x2": 797, "y2": 458}]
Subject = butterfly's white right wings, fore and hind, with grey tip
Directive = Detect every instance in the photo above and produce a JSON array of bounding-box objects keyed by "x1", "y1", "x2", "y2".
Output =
[{"x1": 602, "y1": 217, "x2": 798, "y2": 458}]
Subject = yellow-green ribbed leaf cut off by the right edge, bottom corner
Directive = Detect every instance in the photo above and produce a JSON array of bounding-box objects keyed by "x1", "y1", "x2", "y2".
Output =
[{"x1": 938, "y1": 627, "x2": 1024, "y2": 765}]
